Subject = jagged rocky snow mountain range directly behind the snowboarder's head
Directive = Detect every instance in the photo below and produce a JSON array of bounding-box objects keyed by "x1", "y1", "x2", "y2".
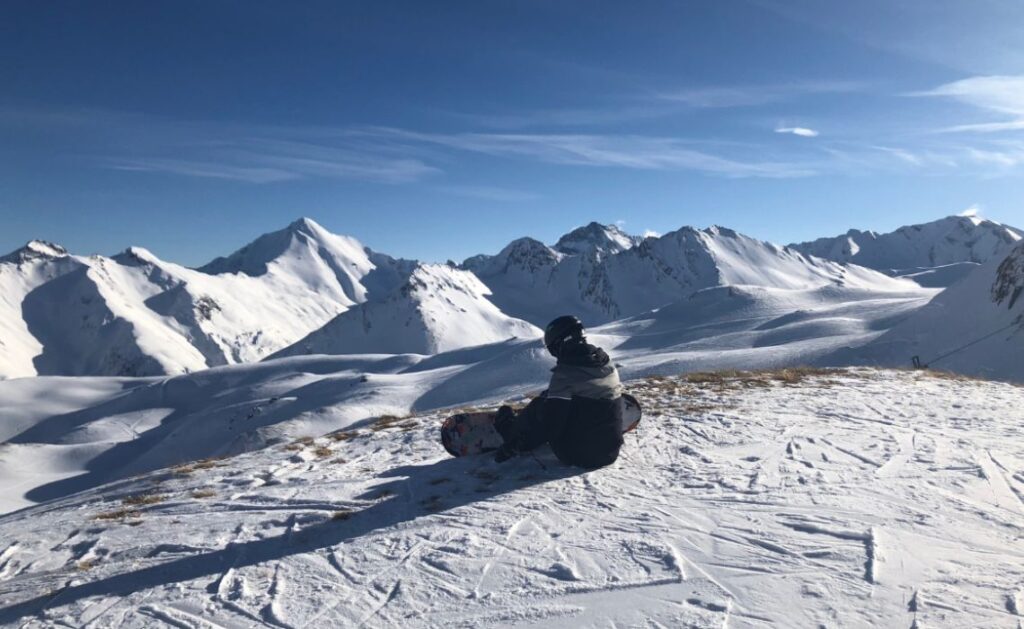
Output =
[{"x1": 464, "y1": 226, "x2": 911, "y2": 325}]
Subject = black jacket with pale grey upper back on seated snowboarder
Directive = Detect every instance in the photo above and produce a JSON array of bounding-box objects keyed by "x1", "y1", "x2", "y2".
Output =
[{"x1": 516, "y1": 342, "x2": 623, "y2": 468}]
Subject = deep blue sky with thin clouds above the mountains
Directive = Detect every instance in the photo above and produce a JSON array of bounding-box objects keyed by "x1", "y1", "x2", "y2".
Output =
[{"x1": 0, "y1": 0, "x2": 1024, "y2": 264}]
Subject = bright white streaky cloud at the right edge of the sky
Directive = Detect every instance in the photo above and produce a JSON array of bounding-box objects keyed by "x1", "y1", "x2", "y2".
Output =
[{"x1": 911, "y1": 76, "x2": 1024, "y2": 132}]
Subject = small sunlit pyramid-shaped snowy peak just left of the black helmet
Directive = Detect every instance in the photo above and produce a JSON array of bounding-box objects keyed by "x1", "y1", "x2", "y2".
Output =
[{"x1": 274, "y1": 264, "x2": 541, "y2": 358}]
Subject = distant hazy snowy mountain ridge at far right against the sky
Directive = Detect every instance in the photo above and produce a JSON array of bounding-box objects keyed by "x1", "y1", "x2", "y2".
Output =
[{"x1": 790, "y1": 216, "x2": 1024, "y2": 287}]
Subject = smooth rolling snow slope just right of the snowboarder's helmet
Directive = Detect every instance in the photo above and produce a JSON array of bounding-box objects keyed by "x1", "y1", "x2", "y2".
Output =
[{"x1": 595, "y1": 286, "x2": 935, "y2": 373}]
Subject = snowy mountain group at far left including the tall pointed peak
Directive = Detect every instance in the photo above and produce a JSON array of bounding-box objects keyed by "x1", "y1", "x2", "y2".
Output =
[{"x1": 0, "y1": 219, "x2": 414, "y2": 377}]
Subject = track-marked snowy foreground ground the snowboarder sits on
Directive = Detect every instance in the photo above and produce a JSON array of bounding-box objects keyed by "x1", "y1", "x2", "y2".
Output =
[{"x1": 0, "y1": 369, "x2": 1024, "y2": 628}]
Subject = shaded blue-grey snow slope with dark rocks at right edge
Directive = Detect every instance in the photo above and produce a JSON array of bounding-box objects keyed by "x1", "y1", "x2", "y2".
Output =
[{"x1": 830, "y1": 243, "x2": 1024, "y2": 381}]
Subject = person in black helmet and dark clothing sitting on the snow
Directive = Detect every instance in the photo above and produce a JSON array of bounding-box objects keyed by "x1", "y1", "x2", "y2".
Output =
[{"x1": 495, "y1": 316, "x2": 623, "y2": 468}]
